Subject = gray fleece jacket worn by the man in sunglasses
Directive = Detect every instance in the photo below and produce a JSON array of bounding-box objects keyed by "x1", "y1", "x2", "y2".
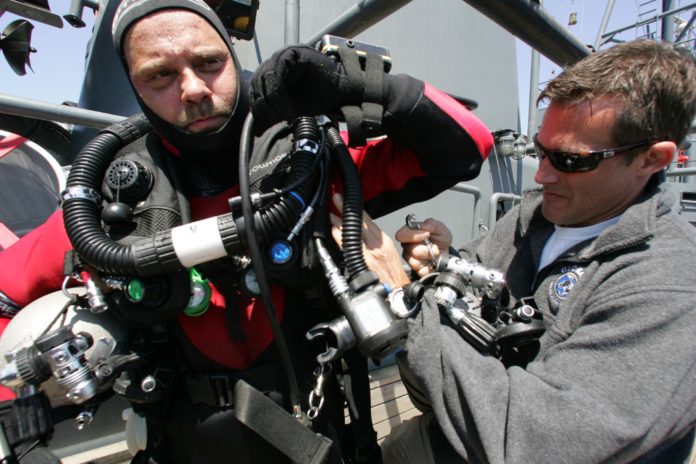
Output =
[{"x1": 406, "y1": 181, "x2": 696, "y2": 464}]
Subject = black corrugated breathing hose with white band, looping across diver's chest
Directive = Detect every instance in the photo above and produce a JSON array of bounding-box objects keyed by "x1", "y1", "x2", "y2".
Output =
[{"x1": 63, "y1": 115, "x2": 319, "y2": 277}]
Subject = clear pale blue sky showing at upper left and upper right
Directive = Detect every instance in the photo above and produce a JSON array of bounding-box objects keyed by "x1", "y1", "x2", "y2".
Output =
[{"x1": 0, "y1": 0, "x2": 692, "y2": 132}]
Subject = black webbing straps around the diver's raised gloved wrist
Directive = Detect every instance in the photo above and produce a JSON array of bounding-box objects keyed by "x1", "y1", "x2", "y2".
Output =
[{"x1": 338, "y1": 47, "x2": 384, "y2": 146}]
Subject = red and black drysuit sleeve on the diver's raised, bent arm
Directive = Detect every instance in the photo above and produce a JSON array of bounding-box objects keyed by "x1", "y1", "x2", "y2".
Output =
[{"x1": 344, "y1": 74, "x2": 493, "y2": 217}]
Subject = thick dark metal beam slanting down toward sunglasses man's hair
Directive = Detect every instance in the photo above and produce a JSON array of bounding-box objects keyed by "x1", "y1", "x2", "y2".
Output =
[{"x1": 464, "y1": 0, "x2": 590, "y2": 67}]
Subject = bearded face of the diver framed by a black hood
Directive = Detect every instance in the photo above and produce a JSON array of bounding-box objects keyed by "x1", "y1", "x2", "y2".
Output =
[{"x1": 123, "y1": 10, "x2": 237, "y2": 134}]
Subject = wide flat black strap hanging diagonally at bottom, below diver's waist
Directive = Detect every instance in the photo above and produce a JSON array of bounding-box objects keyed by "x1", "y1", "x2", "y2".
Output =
[{"x1": 234, "y1": 380, "x2": 332, "y2": 464}]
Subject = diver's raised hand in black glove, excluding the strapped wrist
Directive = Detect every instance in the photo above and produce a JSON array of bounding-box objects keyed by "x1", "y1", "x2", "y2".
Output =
[{"x1": 249, "y1": 46, "x2": 363, "y2": 131}]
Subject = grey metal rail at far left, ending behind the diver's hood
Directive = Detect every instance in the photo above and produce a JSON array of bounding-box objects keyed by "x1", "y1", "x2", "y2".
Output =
[{"x1": 0, "y1": 93, "x2": 126, "y2": 129}]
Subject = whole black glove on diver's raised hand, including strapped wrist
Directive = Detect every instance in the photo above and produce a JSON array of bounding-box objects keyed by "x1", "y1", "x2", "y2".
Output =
[{"x1": 249, "y1": 46, "x2": 384, "y2": 143}]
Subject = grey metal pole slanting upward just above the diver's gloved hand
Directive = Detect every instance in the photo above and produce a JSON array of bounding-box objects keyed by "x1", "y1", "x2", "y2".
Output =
[{"x1": 304, "y1": 0, "x2": 411, "y2": 47}]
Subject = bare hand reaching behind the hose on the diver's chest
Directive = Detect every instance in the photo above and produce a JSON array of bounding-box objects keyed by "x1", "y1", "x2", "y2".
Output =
[{"x1": 331, "y1": 194, "x2": 411, "y2": 289}]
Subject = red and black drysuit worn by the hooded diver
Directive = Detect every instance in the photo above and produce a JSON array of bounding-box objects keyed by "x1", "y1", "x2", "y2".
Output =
[{"x1": 0, "y1": 75, "x2": 492, "y2": 462}]
